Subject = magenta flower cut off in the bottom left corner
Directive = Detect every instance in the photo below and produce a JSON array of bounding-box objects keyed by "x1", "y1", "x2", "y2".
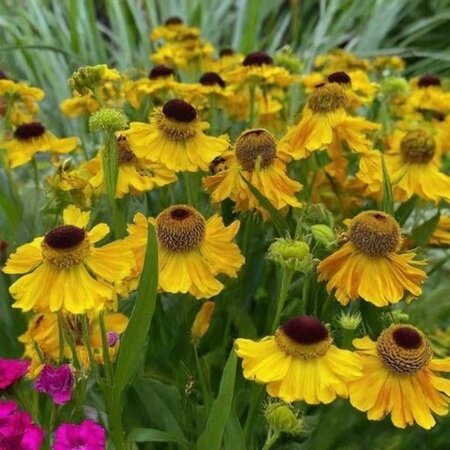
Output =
[{"x1": 0, "y1": 401, "x2": 44, "y2": 450}]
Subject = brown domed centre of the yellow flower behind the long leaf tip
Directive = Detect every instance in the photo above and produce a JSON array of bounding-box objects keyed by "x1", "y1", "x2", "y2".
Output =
[{"x1": 156, "y1": 205, "x2": 206, "y2": 252}]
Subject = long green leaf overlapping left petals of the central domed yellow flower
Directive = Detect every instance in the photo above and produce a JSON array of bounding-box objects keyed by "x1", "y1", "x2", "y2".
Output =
[{"x1": 114, "y1": 223, "x2": 158, "y2": 392}]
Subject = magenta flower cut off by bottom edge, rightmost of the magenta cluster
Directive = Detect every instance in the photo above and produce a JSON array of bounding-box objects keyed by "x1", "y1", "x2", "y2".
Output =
[{"x1": 52, "y1": 419, "x2": 106, "y2": 450}]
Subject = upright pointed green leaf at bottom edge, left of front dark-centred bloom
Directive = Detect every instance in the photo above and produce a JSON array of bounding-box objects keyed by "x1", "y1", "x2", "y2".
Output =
[{"x1": 196, "y1": 349, "x2": 237, "y2": 450}]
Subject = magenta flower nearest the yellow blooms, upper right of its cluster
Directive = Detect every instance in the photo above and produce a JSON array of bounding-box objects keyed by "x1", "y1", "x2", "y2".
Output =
[{"x1": 34, "y1": 364, "x2": 74, "y2": 405}]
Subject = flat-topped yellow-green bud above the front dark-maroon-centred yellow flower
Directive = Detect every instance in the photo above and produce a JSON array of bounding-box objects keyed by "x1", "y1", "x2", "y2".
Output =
[{"x1": 267, "y1": 238, "x2": 313, "y2": 272}]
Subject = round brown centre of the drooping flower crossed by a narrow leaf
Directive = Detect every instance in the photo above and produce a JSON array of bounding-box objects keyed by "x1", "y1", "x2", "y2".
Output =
[{"x1": 236, "y1": 128, "x2": 277, "y2": 172}]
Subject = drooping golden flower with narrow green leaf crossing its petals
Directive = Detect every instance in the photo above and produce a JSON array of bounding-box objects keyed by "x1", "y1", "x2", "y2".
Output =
[{"x1": 203, "y1": 128, "x2": 302, "y2": 218}]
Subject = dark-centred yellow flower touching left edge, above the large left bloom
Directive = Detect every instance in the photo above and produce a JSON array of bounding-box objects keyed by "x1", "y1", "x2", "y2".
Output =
[{"x1": 0, "y1": 122, "x2": 78, "y2": 168}]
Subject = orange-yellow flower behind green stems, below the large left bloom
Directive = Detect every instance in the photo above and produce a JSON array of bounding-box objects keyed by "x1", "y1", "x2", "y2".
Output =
[{"x1": 19, "y1": 312, "x2": 128, "y2": 378}]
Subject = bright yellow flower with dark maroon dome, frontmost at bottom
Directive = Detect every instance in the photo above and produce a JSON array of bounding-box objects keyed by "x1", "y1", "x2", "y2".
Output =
[{"x1": 235, "y1": 316, "x2": 361, "y2": 404}]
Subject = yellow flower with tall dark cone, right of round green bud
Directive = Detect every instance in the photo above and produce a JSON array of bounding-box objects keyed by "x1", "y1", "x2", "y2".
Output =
[{"x1": 121, "y1": 99, "x2": 228, "y2": 172}]
